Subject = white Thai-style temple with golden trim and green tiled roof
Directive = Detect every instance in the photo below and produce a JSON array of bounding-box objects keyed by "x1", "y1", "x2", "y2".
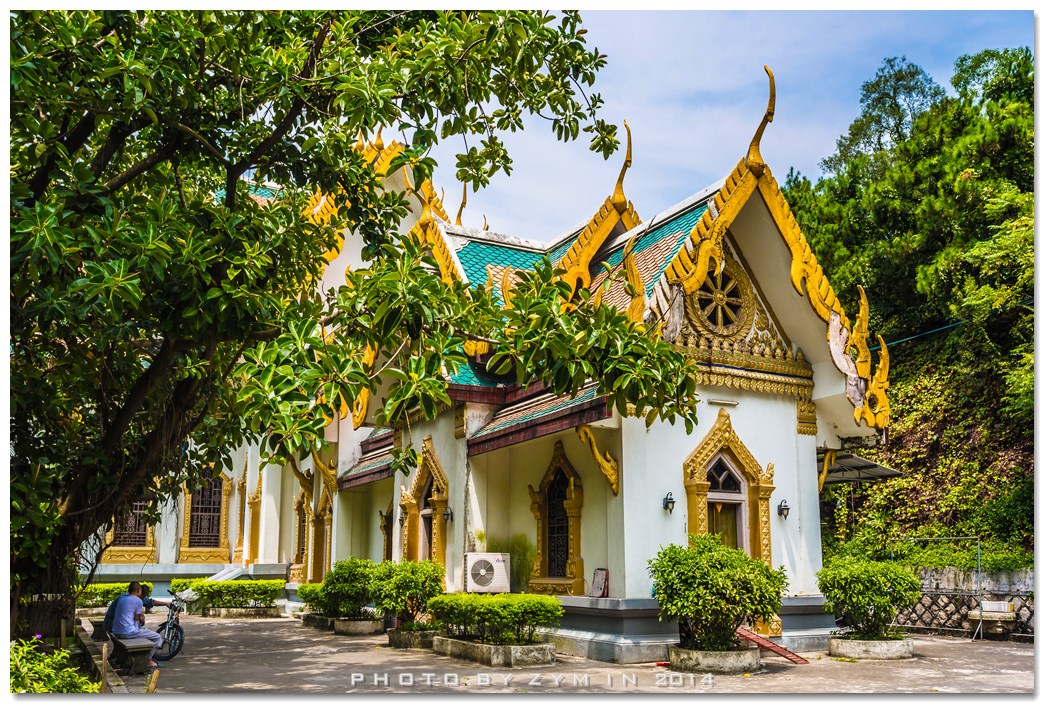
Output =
[{"x1": 91, "y1": 73, "x2": 888, "y2": 663}]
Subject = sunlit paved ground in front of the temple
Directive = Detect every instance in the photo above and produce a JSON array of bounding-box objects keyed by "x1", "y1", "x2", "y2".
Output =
[{"x1": 116, "y1": 615, "x2": 1035, "y2": 698}]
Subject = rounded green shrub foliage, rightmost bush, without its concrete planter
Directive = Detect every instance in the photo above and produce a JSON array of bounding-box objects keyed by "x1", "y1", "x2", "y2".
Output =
[{"x1": 815, "y1": 557, "x2": 921, "y2": 639}]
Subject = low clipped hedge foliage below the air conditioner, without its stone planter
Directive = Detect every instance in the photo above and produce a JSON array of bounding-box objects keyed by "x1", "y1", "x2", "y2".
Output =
[{"x1": 428, "y1": 592, "x2": 565, "y2": 644}]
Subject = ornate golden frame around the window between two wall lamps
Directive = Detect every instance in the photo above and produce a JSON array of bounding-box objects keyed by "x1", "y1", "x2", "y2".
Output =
[{"x1": 683, "y1": 408, "x2": 776, "y2": 566}]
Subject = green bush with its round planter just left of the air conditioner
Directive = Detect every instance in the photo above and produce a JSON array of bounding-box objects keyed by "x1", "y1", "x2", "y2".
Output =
[{"x1": 370, "y1": 561, "x2": 446, "y2": 648}]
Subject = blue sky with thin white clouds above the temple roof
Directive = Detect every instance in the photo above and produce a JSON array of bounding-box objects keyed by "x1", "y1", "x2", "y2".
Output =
[{"x1": 425, "y1": 9, "x2": 1036, "y2": 241}]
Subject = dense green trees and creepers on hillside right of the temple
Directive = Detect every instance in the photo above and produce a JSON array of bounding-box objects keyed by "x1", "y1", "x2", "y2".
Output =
[{"x1": 784, "y1": 47, "x2": 1034, "y2": 569}]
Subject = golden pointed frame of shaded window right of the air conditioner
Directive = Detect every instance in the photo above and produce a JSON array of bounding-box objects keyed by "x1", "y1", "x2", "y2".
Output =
[{"x1": 528, "y1": 440, "x2": 584, "y2": 595}]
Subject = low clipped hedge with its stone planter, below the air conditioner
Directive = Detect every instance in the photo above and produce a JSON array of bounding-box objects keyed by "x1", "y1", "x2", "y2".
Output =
[{"x1": 428, "y1": 592, "x2": 564, "y2": 667}]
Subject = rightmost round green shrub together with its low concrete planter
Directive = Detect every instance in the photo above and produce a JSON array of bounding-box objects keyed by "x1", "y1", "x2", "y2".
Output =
[{"x1": 815, "y1": 557, "x2": 921, "y2": 659}]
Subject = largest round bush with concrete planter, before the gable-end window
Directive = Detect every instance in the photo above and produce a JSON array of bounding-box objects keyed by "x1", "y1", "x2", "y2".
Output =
[{"x1": 648, "y1": 535, "x2": 787, "y2": 674}]
